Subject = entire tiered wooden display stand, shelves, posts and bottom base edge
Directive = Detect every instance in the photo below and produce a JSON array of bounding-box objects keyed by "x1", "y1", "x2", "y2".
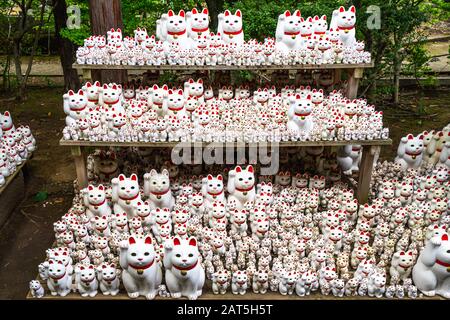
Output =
[{"x1": 27, "y1": 63, "x2": 398, "y2": 300}]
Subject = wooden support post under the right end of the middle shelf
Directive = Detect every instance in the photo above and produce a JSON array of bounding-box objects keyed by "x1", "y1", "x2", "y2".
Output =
[{"x1": 356, "y1": 146, "x2": 380, "y2": 204}]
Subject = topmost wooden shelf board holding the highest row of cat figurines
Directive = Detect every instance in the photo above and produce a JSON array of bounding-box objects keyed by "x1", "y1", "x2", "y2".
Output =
[{"x1": 72, "y1": 62, "x2": 374, "y2": 71}]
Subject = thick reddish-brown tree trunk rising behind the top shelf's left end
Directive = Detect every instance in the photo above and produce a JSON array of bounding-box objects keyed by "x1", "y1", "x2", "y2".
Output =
[{"x1": 89, "y1": 0, "x2": 128, "y2": 83}]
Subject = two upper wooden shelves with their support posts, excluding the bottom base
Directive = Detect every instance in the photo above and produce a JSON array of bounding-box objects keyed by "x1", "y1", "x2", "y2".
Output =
[{"x1": 64, "y1": 63, "x2": 392, "y2": 203}]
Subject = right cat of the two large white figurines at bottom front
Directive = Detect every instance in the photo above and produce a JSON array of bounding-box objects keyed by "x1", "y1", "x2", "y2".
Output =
[{"x1": 164, "y1": 236, "x2": 205, "y2": 300}]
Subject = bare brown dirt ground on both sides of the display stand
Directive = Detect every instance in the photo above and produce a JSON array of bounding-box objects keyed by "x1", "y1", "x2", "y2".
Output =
[{"x1": 0, "y1": 88, "x2": 450, "y2": 299}]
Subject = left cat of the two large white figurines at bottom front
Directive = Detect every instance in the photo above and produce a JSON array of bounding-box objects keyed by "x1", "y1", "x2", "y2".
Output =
[{"x1": 120, "y1": 236, "x2": 163, "y2": 300}]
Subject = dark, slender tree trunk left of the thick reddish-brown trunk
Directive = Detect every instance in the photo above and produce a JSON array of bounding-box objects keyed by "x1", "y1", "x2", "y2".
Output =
[{"x1": 52, "y1": 0, "x2": 80, "y2": 91}]
